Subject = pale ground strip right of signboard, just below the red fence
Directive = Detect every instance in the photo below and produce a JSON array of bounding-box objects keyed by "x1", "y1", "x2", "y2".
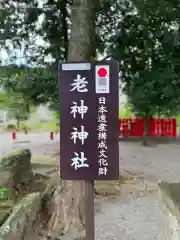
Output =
[{"x1": 119, "y1": 141, "x2": 180, "y2": 182}]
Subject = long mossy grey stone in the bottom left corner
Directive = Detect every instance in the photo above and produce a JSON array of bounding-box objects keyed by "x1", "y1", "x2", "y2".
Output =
[{"x1": 0, "y1": 192, "x2": 42, "y2": 240}]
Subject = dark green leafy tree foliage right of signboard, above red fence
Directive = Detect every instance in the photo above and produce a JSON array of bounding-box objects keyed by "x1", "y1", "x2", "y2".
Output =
[{"x1": 110, "y1": 0, "x2": 180, "y2": 115}]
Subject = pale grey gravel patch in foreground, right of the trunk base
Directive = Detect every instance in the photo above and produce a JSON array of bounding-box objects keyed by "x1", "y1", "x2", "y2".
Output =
[{"x1": 96, "y1": 196, "x2": 172, "y2": 240}]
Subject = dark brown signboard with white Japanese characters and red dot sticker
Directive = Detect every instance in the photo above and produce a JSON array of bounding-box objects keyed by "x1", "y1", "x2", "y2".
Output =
[{"x1": 59, "y1": 61, "x2": 119, "y2": 180}]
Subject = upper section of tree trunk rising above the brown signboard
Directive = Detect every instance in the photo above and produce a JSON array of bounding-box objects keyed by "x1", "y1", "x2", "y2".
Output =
[{"x1": 68, "y1": 0, "x2": 96, "y2": 62}]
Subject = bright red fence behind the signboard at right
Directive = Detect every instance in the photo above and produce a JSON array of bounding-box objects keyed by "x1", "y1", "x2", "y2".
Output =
[{"x1": 119, "y1": 118, "x2": 176, "y2": 137}]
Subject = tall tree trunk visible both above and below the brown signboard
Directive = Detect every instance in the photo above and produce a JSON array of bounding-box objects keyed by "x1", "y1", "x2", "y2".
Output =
[{"x1": 44, "y1": 0, "x2": 97, "y2": 236}]
